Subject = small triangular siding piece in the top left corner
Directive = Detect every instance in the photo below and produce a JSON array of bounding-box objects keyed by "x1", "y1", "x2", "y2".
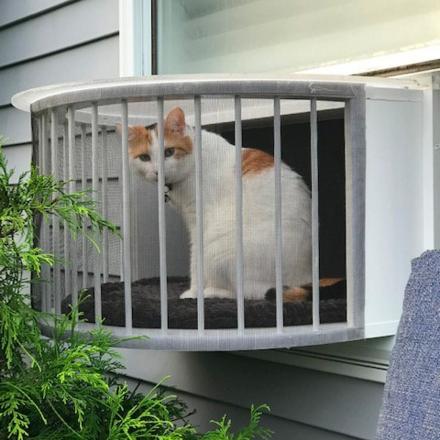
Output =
[{"x1": 0, "y1": 0, "x2": 78, "y2": 28}]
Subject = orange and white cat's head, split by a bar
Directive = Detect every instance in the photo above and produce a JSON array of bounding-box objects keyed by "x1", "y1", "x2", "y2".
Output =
[{"x1": 118, "y1": 107, "x2": 194, "y2": 184}]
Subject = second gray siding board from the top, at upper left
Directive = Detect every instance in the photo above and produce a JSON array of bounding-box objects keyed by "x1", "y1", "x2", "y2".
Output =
[{"x1": 0, "y1": 0, "x2": 118, "y2": 68}]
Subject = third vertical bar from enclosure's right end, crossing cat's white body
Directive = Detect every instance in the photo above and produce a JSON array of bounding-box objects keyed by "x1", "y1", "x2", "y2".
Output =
[{"x1": 234, "y1": 96, "x2": 245, "y2": 333}]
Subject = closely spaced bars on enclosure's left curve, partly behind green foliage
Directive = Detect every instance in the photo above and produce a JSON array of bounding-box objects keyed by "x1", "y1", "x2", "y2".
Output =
[{"x1": 38, "y1": 107, "x2": 113, "y2": 319}]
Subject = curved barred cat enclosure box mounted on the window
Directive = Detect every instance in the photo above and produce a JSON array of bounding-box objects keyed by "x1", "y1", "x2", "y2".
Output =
[{"x1": 14, "y1": 77, "x2": 426, "y2": 350}]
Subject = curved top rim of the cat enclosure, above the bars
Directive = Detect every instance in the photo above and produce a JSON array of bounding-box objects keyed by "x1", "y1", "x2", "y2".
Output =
[{"x1": 12, "y1": 77, "x2": 365, "y2": 113}]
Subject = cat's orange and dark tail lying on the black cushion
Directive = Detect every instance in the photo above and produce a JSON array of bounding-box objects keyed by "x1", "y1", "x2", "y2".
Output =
[{"x1": 266, "y1": 278, "x2": 347, "y2": 302}]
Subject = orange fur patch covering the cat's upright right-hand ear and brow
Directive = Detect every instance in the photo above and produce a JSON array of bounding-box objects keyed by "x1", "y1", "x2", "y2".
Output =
[{"x1": 164, "y1": 107, "x2": 193, "y2": 159}]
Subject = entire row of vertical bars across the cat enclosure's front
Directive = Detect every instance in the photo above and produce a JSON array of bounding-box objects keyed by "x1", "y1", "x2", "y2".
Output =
[{"x1": 35, "y1": 95, "x2": 353, "y2": 333}]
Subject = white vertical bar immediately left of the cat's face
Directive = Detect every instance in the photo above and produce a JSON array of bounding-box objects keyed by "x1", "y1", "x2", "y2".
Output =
[{"x1": 121, "y1": 100, "x2": 133, "y2": 331}]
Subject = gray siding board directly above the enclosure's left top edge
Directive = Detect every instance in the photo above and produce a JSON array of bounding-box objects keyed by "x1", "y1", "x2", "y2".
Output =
[{"x1": 0, "y1": 36, "x2": 119, "y2": 106}]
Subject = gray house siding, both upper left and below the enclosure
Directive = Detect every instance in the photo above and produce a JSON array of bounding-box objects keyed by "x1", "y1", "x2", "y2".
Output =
[{"x1": 0, "y1": 0, "x2": 383, "y2": 440}]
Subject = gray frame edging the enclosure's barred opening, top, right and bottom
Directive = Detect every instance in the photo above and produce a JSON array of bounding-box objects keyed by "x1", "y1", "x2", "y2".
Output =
[{"x1": 13, "y1": 77, "x2": 366, "y2": 350}]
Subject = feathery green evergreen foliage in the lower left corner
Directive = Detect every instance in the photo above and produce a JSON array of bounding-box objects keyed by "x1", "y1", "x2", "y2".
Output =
[{"x1": 0, "y1": 148, "x2": 270, "y2": 440}]
